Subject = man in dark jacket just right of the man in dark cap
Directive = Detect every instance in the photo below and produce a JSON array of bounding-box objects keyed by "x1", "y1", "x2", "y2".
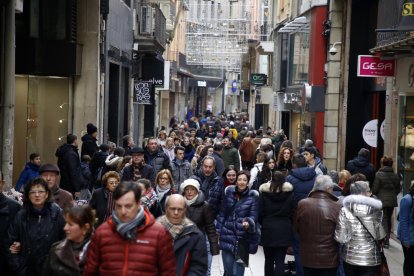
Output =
[{"x1": 144, "y1": 137, "x2": 172, "y2": 175}]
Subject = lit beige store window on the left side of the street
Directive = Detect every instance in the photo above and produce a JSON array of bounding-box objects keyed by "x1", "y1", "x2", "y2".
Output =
[{"x1": 13, "y1": 76, "x2": 71, "y2": 183}]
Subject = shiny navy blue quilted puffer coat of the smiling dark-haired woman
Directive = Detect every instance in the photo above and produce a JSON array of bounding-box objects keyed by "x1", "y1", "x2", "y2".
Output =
[{"x1": 216, "y1": 186, "x2": 260, "y2": 255}]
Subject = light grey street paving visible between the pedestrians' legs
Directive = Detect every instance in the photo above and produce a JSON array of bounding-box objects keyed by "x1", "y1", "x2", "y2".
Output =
[{"x1": 211, "y1": 239, "x2": 404, "y2": 276}]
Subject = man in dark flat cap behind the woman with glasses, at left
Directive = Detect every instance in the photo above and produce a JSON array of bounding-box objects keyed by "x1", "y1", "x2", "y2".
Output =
[{"x1": 39, "y1": 164, "x2": 73, "y2": 210}]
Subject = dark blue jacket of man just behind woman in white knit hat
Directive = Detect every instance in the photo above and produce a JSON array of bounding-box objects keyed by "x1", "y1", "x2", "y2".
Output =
[{"x1": 191, "y1": 170, "x2": 224, "y2": 216}]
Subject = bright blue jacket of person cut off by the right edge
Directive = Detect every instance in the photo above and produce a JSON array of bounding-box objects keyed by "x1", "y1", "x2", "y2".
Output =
[{"x1": 397, "y1": 194, "x2": 414, "y2": 246}]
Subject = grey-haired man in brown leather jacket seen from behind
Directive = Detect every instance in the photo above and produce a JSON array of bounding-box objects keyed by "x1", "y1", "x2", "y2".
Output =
[{"x1": 294, "y1": 175, "x2": 341, "y2": 276}]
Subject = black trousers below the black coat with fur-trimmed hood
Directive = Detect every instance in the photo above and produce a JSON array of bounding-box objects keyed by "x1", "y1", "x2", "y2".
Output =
[{"x1": 263, "y1": 247, "x2": 287, "y2": 276}]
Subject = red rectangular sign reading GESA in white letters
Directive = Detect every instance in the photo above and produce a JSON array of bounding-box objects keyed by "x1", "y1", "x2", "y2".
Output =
[{"x1": 357, "y1": 55, "x2": 395, "y2": 77}]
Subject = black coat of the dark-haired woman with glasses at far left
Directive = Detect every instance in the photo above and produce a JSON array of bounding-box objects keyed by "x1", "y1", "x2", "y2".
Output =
[{"x1": 7, "y1": 203, "x2": 65, "y2": 276}]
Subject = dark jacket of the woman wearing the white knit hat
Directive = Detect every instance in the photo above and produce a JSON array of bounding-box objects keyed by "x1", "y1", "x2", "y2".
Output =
[{"x1": 186, "y1": 191, "x2": 220, "y2": 256}]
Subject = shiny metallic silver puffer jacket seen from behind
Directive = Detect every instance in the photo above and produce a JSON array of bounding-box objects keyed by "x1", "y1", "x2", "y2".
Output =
[{"x1": 335, "y1": 195, "x2": 386, "y2": 266}]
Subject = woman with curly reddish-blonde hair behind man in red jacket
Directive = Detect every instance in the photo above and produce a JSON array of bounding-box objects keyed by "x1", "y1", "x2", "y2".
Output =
[{"x1": 89, "y1": 171, "x2": 121, "y2": 225}]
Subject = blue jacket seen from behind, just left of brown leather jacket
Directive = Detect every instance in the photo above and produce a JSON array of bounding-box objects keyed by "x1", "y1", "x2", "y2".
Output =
[{"x1": 286, "y1": 167, "x2": 316, "y2": 202}]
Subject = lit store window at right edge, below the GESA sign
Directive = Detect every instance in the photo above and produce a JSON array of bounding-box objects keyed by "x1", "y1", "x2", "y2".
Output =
[{"x1": 398, "y1": 96, "x2": 414, "y2": 194}]
